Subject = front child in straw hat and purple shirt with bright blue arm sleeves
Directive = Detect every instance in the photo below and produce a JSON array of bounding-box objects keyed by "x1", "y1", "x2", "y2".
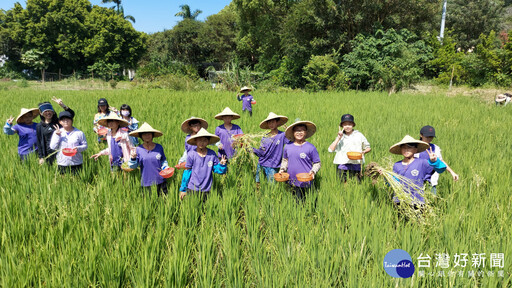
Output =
[{"x1": 180, "y1": 128, "x2": 227, "y2": 201}]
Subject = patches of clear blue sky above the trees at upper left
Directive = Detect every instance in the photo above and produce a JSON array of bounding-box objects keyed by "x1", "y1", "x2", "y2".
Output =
[{"x1": 0, "y1": 0, "x2": 231, "y2": 33}]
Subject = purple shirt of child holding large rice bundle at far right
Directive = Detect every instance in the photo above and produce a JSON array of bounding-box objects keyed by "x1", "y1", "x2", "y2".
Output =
[{"x1": 393, "y1": 158, "x2": 434, "y2": 203}]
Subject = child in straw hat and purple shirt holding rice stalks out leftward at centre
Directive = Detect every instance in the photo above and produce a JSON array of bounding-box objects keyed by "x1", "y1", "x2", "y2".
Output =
[{"x1": 253, "y1": 112, "x2": 290, "y2": 184}]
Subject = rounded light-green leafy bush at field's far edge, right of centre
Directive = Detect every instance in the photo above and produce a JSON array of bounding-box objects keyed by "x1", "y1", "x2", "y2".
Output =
[{"x1": 341, "y1": 29, "x2": 432, "y2": 92}]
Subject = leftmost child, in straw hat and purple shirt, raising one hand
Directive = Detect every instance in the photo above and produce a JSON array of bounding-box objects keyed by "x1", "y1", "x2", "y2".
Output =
[{"x1": 4, "y1": 108, "x2": 39, "y2": 160}]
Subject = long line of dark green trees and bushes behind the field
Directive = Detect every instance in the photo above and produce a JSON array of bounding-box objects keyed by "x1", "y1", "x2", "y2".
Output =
[{"x1": 0, "y1": 0, "x2": 512, "y2": 91}]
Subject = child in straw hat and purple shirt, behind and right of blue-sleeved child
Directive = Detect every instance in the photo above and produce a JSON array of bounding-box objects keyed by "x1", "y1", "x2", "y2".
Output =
[{"x1": 215, "y1": 107, "x2": 244, "y2": 159}]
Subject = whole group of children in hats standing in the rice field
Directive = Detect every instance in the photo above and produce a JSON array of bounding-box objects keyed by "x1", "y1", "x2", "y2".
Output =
[{"x1": 4, "y1": 87, "x2": 459, "y2": 202}]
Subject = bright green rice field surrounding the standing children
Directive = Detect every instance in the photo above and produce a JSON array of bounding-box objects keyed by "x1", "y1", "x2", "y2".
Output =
[{"x1": 0, "y1": 88, "x2": 512, "y2": 287}]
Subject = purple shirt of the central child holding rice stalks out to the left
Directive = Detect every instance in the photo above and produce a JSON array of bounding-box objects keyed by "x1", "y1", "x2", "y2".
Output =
[{"x1": 253, "y1": 131, "x2": 290, "y2": 168}]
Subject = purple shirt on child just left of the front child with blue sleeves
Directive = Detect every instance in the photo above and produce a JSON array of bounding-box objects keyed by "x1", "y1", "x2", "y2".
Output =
[{"x1": 137, "y1": 143, "x2": 166, "y2": 187}]
